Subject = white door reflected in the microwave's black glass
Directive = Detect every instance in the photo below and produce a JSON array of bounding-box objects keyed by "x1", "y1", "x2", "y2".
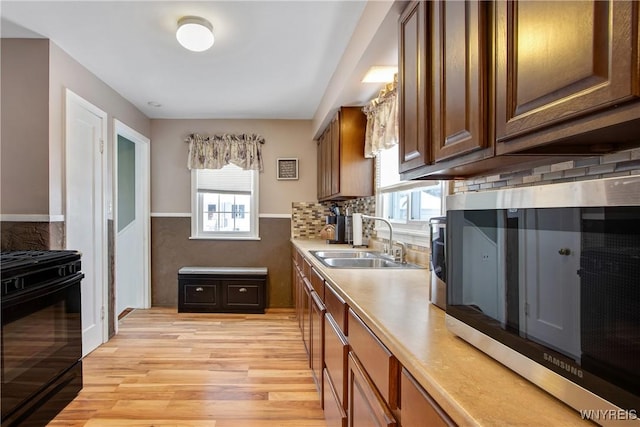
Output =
[{"x1": 523, "y1": 209, "x2": 581, "y2": 360}]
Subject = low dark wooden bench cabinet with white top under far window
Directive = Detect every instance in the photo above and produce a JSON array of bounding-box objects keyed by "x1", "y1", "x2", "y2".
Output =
[{"x1": 178, "y1": 267, "x2": 268, "y2": 313}]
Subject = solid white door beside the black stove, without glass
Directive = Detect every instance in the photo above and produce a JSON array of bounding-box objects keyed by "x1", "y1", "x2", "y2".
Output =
[{"x1": 65, "y1": 90, "x2": 107, "y2": 356}]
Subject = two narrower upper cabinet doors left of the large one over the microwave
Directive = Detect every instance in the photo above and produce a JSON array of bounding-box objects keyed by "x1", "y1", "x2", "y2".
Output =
[{"x1": 399, "y1": 1, "x2": 494, "y2": 179}]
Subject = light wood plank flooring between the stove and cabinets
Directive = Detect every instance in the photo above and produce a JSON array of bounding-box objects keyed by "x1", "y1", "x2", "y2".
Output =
[{"x1": 49, "y1": 308, "x2": 325, "y2": 427}]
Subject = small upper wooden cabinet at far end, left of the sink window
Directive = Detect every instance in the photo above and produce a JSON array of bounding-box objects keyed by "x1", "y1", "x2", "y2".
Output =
[{"x1": 318, "y1": 107, "x2": 373, "y2": 201}]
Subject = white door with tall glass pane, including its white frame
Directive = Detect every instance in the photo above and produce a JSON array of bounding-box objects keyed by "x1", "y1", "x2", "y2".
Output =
[{"x1": 114, "y1": 120, "x2": 151, "y2": 315}]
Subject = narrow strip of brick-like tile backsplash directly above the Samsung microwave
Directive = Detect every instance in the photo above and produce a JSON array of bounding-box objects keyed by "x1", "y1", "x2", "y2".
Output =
[{"x1": 453, "y1": 148, "x2": 640, "y2": 193}]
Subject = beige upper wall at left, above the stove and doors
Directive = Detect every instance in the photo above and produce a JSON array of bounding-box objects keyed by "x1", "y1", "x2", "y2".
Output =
[{"x1": 0, "y1": 39, "x2": 151, "y2": 219}]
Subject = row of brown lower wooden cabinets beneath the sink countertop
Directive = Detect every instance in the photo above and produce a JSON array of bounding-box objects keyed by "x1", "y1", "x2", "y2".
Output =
[{"x1": 290, "y1": 247, "x2": 455, "y2": 427}]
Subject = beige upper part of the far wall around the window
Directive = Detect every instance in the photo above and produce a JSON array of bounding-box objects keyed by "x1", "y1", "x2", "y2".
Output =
[{"x1": 151, "y1": 119, "x2": 316, "y2": 216}]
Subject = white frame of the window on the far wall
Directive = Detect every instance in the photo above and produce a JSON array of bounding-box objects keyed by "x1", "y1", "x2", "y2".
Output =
[{"x1": 190, "y1": 169, "x2": 260, "y2": 240}]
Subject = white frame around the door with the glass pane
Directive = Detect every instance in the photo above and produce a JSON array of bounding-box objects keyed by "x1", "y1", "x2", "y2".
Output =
[{"x1": 112, "y1": 119, "x2": 151, "y2": 333}]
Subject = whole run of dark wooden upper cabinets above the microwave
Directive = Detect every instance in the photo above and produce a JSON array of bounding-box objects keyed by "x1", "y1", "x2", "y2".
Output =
[{"x1": 398, "y1": 0, "x2": 640, "y2": 179}]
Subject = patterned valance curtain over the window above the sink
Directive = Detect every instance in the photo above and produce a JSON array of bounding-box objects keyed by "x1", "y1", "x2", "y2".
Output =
[{"x1": 362, "y1": 77, "x2": 398, "y2": 158}]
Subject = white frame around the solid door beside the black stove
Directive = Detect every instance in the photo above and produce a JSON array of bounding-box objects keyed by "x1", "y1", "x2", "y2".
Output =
[{"x1": 64, "y1": 88, "x2": 110, "y2": 356}]
